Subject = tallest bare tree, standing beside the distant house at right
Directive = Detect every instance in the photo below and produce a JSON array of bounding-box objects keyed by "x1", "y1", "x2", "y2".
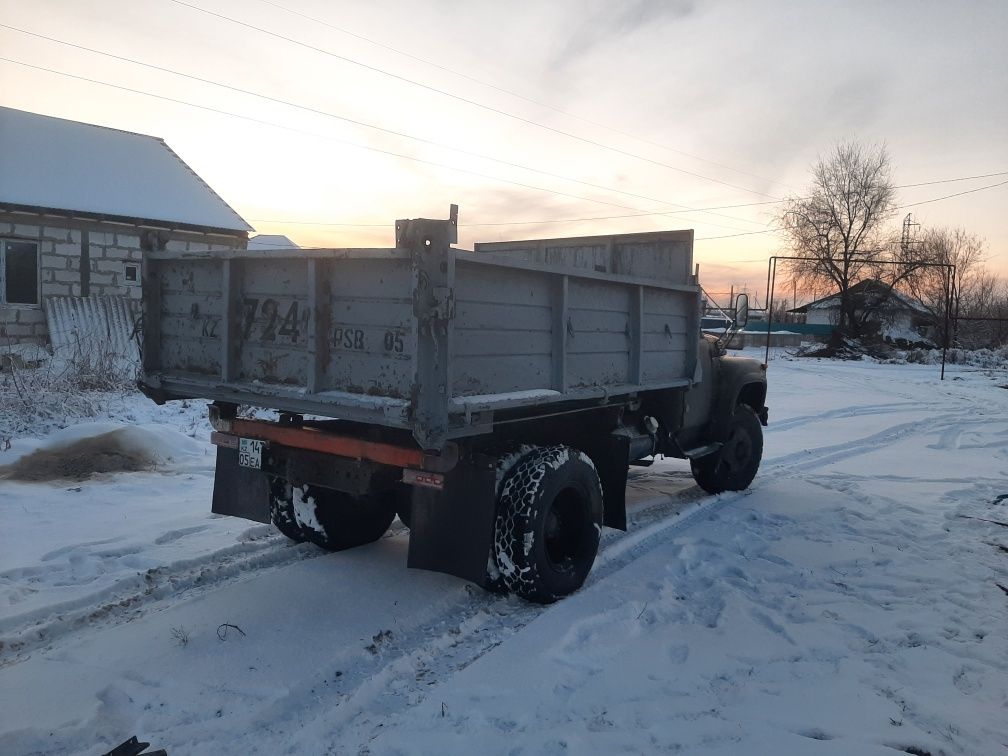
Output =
[{"x1": 779, "y1": 141, "x2": 908, "y2": 334}]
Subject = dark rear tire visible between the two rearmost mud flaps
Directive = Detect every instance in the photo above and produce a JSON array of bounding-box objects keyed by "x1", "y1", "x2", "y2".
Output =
[{"x1": 292, "y1": 486, "x2": 395, "y2": 551}]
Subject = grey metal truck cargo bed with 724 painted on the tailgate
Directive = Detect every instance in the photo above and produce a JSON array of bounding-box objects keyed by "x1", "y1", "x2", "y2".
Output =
[{"x1": 141, "y1": 214, "x2": 700, "y2": 449}]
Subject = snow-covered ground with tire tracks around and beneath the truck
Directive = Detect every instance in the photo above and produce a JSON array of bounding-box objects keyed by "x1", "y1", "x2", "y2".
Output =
[{"x1": 0, "y1": 353, "x2": 1008, "y2": 756}]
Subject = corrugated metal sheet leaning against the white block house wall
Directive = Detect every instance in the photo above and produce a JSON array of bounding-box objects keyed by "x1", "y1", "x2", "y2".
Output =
[{"x1": 43, "y1": 296, "x2": 140, "y2": 364}]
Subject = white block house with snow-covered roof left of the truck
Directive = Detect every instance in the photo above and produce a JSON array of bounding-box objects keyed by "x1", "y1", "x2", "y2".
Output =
[{"x1": 0, "y1": 107, "x2": 252, "y2": 345}]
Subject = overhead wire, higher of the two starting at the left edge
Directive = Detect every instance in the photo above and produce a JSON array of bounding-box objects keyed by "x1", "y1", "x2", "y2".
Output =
[{"x1": 0, "y1": 23, "x2": 763, "y2": 230}]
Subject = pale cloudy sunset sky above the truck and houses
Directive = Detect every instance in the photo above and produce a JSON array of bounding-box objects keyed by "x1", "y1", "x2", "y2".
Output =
[{"x1": 0, "y1": 0, "x2": 1008, "y2": 299}]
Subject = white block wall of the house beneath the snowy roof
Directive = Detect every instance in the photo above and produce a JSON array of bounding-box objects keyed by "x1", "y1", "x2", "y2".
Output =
[{"x1": 0, "y1": 211, "x2": 247, "y2": 347}]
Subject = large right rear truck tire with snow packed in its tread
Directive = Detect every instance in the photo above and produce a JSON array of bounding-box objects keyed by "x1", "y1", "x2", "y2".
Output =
[{"x1": 494, "y1": 446, "x2": 602, "y2": 604}]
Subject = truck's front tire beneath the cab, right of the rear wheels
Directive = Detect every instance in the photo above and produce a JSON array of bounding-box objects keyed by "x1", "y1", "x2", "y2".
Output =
[{"x1": 689, "y1": 404, "x2": 763, "y2": 494}]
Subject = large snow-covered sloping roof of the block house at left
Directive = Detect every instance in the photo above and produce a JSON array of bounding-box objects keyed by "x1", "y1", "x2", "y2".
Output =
[{"x1": 0, "y1": 107, "x2": 253, "y2": 232}]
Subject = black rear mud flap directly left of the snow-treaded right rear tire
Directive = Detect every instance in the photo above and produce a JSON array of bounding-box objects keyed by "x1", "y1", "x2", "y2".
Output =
[{"x1": 406, "y1": 455, "x2": 497, "y2": 588}]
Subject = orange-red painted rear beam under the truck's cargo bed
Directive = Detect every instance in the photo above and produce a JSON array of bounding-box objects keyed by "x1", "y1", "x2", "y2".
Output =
[{"x1": 231, "y1": 418, "x2": 423, "y2": 469}]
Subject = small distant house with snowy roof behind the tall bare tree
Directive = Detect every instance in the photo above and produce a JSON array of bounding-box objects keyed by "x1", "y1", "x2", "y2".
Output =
[{"x1": 788, "y1": 280, "x2": 933, "y2": 342}]
